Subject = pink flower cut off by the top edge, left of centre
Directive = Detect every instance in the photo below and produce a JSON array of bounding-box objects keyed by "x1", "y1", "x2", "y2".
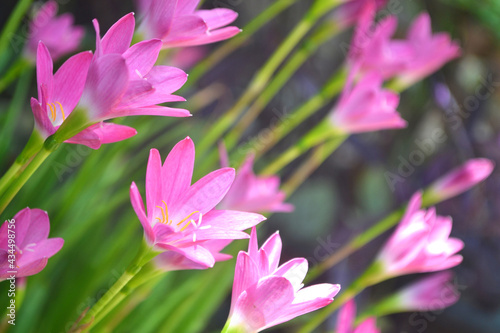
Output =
[{"x1": 137, "y1": 0, "x2": 240, "y2": 48}]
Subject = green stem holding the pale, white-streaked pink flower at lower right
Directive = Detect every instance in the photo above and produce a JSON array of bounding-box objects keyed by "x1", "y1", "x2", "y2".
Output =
[{"x1": 297, "y1": 262, "x2": 386, "y2": 333}]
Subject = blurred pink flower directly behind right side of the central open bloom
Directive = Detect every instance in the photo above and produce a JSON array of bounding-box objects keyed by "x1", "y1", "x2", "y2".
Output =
[{"x1": 219, "y1": 145, "x2": 293, "y2": 213}]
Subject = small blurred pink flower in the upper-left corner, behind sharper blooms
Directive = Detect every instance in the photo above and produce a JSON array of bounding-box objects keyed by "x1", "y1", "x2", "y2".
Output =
[{"x1": 24, "y1": 1, "x2": 85, "y2": 61}]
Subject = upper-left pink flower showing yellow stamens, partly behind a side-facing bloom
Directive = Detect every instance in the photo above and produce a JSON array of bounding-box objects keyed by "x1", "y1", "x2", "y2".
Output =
[{"x1": 31, "y1": 42, "x2": 136, "y2": 149}]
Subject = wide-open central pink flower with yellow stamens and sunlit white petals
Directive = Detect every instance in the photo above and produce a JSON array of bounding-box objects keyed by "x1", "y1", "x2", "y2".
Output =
[{"x1": 130, "y1": 137, "x2": 265, "y2": 269}]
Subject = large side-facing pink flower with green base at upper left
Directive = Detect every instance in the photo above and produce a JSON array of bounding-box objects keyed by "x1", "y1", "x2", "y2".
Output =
[{"x1": 42, "y1": 13, "x2": 190, "y2": 142}]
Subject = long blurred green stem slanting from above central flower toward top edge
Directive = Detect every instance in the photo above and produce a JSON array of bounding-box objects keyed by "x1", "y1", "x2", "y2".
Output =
[{"x1": 198, "y1": 0, "x2": 332, "y2": 153}]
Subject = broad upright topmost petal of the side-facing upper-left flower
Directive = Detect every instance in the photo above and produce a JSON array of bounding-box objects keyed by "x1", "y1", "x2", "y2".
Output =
[{"x1": 101, "y1": 13, "x2": 135, "y2": 54}]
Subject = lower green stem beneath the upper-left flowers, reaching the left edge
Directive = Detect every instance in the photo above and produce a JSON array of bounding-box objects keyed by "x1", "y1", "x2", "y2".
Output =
[{"x1": 0, "y1": 134, "x2": 54, "y2": 214}]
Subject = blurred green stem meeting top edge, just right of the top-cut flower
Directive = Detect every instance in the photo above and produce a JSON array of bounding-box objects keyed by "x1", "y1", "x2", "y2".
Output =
[{"x1": 184, "y1": 0, "x2": 297, "y2": 88}]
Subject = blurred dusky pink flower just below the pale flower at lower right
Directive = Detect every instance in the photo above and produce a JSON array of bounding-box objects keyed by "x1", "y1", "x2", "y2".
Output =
[{"x1": 391, "y1": 271, "x2": 460, "y2": 312}]
